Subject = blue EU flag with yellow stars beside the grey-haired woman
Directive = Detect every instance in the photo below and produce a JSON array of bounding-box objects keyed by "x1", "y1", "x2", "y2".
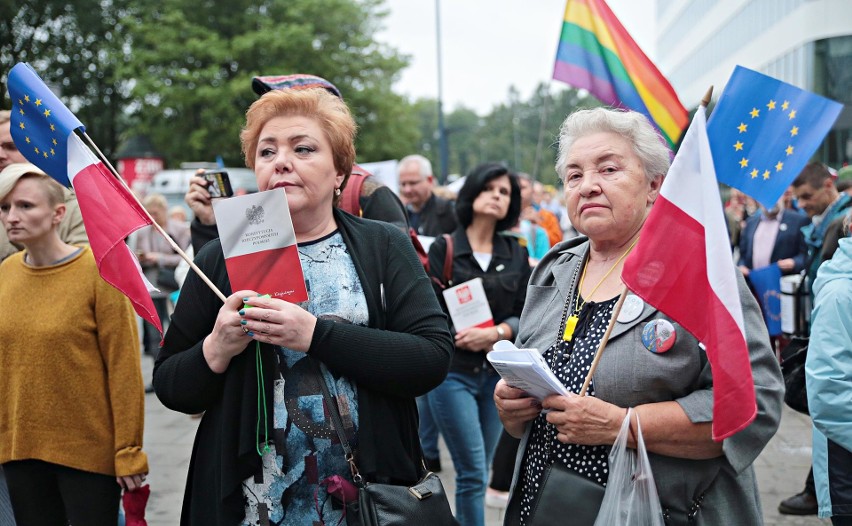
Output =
[{"x1": 707, "y1": 66, "x2": 843, "y2": 208}]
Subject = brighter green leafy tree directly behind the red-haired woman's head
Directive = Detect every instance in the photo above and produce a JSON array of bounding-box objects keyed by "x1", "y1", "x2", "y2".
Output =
[{"x1": 117, "y1": 0, "x2": 414, "y2": 163}]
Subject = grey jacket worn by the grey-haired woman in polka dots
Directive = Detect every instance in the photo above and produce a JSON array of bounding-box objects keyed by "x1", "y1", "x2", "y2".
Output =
[{"x1": 505, "y1": 237, "x2": 784, "y2": 525}]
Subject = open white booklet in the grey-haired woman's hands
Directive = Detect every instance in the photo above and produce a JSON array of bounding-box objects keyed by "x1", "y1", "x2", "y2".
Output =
[{"x1": 486, "y1": 340, "x2": 569, "y2": 400}]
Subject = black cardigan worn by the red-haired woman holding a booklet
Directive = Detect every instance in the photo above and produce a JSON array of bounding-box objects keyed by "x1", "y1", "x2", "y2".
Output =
[{"x1": 154, "y1": 210, "x2": 453, "y2": 525}]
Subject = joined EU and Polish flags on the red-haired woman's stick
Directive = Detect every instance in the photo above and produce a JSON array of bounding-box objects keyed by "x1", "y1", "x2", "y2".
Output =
[{"x1": 8, "y1": 63, "x2": 163, "y2": 334}]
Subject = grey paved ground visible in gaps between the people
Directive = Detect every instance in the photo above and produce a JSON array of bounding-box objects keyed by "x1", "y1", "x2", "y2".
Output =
[{"x1": 138, "y1": 352, "x2": 830, "y2": 526}]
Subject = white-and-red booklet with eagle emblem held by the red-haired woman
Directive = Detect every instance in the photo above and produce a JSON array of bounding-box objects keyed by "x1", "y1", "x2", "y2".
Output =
[{"x1": 213, "y1": 188, "x2": 308, "y2": 303}]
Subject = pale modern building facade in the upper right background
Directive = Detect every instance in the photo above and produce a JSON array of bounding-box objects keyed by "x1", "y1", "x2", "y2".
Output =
[{"x1": 656, "y1": 0, "x2": 852, "y2": 167}]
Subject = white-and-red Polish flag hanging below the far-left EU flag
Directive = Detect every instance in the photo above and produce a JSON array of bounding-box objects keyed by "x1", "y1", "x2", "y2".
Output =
[{"x1": 67, "y1": 132, "x2": 163, "y2": 334}]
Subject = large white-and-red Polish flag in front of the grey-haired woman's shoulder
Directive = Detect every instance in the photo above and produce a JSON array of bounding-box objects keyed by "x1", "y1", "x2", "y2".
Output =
[{"x1": 622, "y1": 106, "x2": 757, "y2": 441}]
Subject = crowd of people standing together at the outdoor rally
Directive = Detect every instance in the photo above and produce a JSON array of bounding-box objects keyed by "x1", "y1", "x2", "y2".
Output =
[{"x1": 0, "y1": 75, "x2": 852, "y2": 526}]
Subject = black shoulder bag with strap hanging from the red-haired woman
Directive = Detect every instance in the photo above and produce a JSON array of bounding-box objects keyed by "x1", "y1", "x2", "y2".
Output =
[{"x1": 310, "y1": 358, "x2": 458, "y2": 526}]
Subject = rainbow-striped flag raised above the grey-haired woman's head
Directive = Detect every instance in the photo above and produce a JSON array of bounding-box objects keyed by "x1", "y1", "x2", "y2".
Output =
[{"x1": 553, "y1": 0, "x2": 689, "y2": 147}]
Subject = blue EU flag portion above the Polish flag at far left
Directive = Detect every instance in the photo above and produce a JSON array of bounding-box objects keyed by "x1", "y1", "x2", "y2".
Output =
[{"x1": 8, "y1": 62, "x2": 85, "y2": 187}]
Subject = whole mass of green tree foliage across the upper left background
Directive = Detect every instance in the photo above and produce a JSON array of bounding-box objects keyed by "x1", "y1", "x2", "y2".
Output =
[{"x1": 0, "y1": 0, "x2": 417, "y2": 164}]
